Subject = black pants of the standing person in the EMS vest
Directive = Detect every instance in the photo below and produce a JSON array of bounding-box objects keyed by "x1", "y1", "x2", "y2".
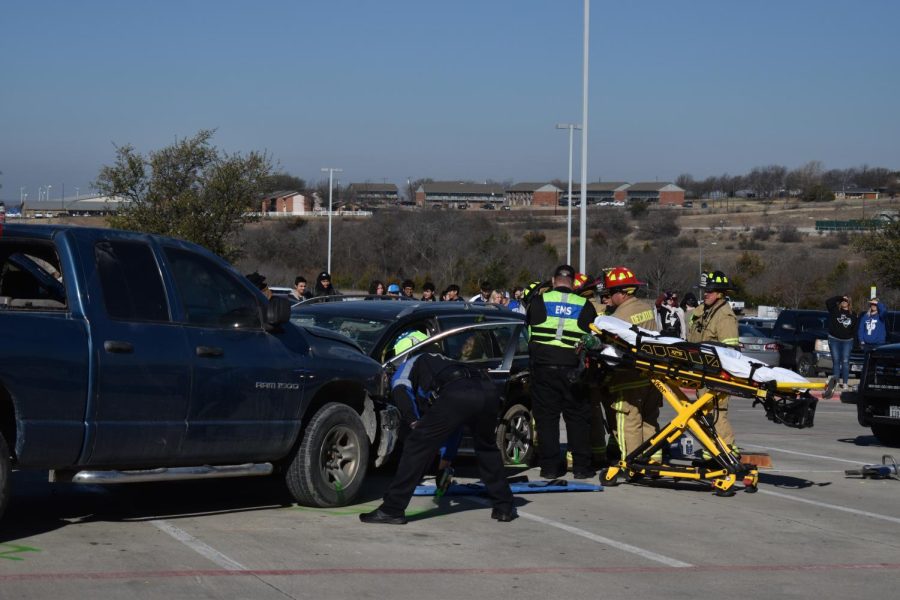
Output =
[{"x1": 531, "y1": 366, "x2": 591, "y2": 473}]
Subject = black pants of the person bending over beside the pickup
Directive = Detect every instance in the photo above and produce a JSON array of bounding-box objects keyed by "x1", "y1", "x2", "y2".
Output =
[{"x1": 381, "y1": 377, "x2": 513, "y2": 516}]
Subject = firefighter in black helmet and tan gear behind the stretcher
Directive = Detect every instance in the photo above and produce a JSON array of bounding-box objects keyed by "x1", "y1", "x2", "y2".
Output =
[{"x1": 687, "y1": 271, "x2": 740, "y2": 453}]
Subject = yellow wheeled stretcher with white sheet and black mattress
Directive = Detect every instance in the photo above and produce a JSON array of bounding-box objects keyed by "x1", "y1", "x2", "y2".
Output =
[{"x1": 587, "y1": 324, "x2": 825, "y2": 496}]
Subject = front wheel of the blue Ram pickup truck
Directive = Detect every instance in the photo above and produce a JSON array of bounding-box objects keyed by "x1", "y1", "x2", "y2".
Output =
[{"x1": 285, "y1": 402, "x2": 369, "y2": 508}]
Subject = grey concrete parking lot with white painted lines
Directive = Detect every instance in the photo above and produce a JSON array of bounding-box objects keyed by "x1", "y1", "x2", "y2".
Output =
[{"x1": 0, "y1": 392, "x2": 900, "y2": 599}]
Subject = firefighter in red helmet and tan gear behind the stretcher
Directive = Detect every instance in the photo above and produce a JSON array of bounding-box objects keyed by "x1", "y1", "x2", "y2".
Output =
[{"x1": 604, "y1": 267, "x2": 662, "y2": 462}]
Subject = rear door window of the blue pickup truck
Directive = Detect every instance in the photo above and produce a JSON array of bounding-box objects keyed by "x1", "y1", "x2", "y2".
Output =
[{"x1": 94, "y1": 240, "x2": 169, "y2": 321}]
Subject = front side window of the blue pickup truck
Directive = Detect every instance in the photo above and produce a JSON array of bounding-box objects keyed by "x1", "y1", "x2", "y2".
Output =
[{"x1": 165, "y1": 248, "x2": 262, "y2": 329}]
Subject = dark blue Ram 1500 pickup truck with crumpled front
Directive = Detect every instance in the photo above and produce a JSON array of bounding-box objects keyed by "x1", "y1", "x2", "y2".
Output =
[{"x1": 0, "y1": 225, "x2": 399, "y2": 514}]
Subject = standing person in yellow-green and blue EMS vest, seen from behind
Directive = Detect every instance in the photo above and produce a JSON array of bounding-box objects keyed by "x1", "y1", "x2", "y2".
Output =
[{"x1": 525, "y1": 265, "x2": 597, "y2": 479}]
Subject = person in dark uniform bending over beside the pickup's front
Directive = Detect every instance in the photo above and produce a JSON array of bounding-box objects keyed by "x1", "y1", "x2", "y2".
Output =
[{"x1": 359, "y1": 353, "x2": 517, "y2": 525}]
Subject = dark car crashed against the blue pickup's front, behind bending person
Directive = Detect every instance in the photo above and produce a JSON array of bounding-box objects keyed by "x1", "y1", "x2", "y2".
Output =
[{"x1": 291, "y1": 296, "x2": 535, "y2": 464}]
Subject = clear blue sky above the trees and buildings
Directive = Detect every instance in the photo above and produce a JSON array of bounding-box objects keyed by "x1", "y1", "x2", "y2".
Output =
[{"x1": 0, "y1": 0, "x2": 900, "y2": 200}]
